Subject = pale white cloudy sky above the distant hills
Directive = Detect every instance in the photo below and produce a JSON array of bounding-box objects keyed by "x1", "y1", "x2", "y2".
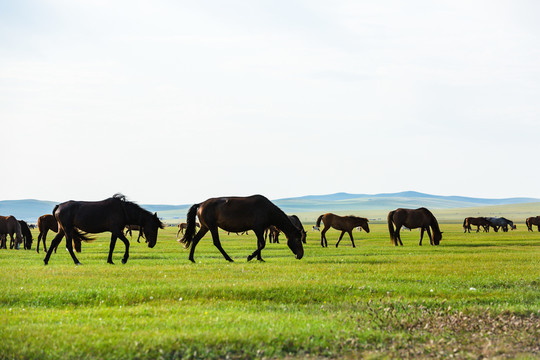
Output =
[{"x1": 0, "y1": 0, "x2": 540, "y2": 204}]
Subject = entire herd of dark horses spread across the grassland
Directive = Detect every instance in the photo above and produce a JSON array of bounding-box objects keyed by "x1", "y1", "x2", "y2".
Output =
[{"x1": 0, "y1": 194, "x2": 540, "y2": 265}]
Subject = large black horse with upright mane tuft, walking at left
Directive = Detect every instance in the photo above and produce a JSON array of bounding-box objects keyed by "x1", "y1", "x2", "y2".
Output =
[{"x1": 43, "y1": 194, "x2": 164, "y2": 265}]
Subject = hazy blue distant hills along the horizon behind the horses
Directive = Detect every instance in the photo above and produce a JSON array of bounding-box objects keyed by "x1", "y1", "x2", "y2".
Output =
[{"x1": 0, "y1": 191, "x2": 540, "y2": 223}]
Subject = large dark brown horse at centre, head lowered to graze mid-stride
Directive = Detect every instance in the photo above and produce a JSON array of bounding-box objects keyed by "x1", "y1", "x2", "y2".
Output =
[{"x1": 180, "y1": 195, "x2": 304, "y2": 262}]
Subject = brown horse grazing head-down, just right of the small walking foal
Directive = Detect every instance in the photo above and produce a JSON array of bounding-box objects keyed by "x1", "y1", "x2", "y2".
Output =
[{"x1": 388, "y1": 208, "x2": 442, "y2": 246}]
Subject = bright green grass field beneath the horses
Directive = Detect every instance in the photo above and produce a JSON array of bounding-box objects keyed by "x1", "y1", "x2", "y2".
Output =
[{"x1": 0, "y1": 223, "x2": 540, "y2": 359}]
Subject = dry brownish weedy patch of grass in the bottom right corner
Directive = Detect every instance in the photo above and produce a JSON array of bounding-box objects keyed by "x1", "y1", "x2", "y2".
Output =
[{"x1": 363, "y1": 303, "x2": 540, "y2": 359}]
